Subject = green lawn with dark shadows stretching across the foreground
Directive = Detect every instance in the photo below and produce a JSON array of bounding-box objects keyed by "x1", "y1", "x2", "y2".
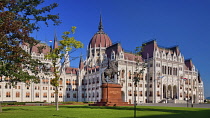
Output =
[{"x1": 0, "y1": 105, "x2": 210, "y2": 118}]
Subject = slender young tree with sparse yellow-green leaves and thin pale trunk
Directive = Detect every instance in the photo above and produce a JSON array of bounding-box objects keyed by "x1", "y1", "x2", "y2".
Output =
[{"x1": 46, "y1": 26, "x2": 83, "y2": 111}]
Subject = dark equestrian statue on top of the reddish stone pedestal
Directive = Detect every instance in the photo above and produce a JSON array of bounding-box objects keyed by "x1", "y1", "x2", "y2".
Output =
[{"x1": 102, "y1": 60, "x2": 118, "y2": 83}]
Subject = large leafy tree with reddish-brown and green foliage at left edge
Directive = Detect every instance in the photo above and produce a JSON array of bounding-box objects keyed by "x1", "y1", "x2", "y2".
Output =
[{"x1": 0, "y1": 0, "x2": 60, "y2": 112}]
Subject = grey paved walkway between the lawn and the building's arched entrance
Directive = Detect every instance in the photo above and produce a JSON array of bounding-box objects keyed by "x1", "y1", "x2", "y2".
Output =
[{"x1": 138, "y1": 103, "x2": 210, "y2": 108}]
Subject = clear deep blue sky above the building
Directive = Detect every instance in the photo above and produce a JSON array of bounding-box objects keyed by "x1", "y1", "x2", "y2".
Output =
[{"x1": 32, "y1": 0, "x2": 210, "y2": 97}]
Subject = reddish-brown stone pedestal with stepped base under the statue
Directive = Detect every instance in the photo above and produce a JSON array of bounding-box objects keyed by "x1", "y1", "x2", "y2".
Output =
[{"x1": 91, "y1": 83, "x2": 132, "y2": 106}]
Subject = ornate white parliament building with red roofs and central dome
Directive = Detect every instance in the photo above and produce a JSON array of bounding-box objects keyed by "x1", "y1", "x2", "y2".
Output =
[{"x1": 0, "y1": 18, "x2": 204, "y2": 104}]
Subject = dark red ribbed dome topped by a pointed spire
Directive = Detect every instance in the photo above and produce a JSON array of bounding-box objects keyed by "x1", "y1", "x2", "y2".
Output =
[{"x1": 88, "y1": 17, "x2": 112, "y2": 48}]
